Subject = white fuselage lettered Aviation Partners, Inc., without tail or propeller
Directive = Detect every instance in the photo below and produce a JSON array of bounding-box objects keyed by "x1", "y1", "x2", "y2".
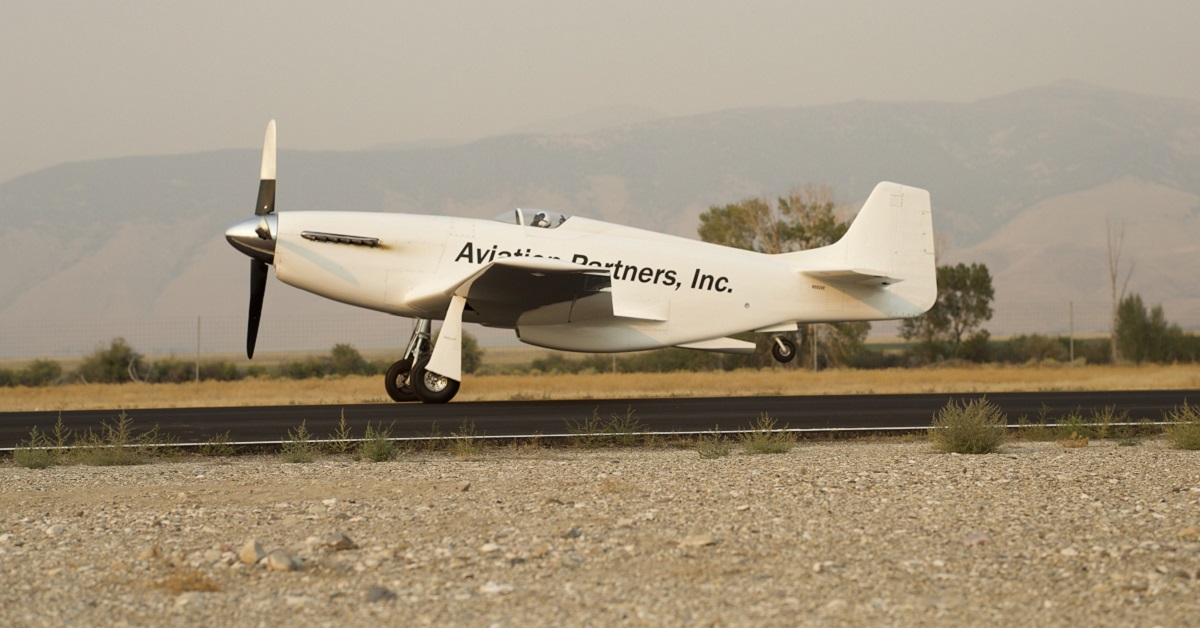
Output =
[{"x1": 262, "y1": 211, "x2": 887, "y2": 352}]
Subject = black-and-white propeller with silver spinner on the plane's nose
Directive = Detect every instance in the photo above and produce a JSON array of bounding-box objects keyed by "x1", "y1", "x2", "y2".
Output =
[{"x1": 226, "y1": 120, "x2": 278, "y2": 358}]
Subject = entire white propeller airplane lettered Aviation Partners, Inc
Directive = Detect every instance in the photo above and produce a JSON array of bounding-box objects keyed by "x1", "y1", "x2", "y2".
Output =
[{"x1": 226, "y1": 120, "x2": 937, "y2": 403}]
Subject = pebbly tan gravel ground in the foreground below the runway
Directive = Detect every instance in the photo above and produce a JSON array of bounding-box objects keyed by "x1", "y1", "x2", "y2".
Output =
[{"x1": 0, "y1": 441, "x2": 1200, "y2": 626}]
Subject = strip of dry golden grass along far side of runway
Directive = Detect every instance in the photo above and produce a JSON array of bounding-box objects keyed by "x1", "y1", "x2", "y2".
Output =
[{"x1": 0, "y1": 365, "x2": 1200, "y2": 412}]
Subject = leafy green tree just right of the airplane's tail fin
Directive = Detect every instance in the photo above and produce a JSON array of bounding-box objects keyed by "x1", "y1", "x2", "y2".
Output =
[{"x1": 900, "y1": 263, "x2": 995, "y2": 361}]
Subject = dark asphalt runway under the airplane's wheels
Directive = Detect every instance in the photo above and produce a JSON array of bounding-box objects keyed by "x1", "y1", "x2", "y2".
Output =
[{"x1": 0, "y1": 390, "x2": 1200, "y2": 449}]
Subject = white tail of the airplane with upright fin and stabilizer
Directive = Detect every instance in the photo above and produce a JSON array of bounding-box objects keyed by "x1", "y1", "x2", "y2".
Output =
[{"x1": 781, "y1": 181, "x2": 937, "y2": 317}]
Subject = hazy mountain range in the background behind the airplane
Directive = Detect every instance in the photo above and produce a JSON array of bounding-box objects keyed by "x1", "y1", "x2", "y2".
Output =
[{"x1": 0, "y1": 83, "x2": 1200, "y2": 357}]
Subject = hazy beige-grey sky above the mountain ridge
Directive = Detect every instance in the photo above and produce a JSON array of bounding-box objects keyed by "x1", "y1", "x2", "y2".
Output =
[{"x1": 0, "y1": 0, "x2": 1200, "y2": 181}]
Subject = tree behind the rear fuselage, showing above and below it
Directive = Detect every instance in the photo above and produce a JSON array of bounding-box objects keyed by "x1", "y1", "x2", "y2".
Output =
[{"x1": 697, "y1": 185, "x2": 871, "y2": 364}]
